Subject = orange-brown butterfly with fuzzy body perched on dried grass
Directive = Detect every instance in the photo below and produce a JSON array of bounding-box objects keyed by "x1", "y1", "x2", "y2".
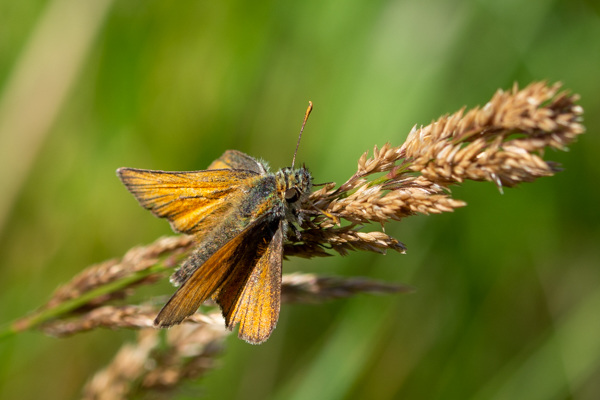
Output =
[{"x1": 117, "y1": 102, "x2": 312, "y2": 344}]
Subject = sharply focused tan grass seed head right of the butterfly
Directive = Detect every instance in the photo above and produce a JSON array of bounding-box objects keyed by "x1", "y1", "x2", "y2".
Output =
[{"x1": 289, "y1": 82, "x2": 585, "y2": 256}]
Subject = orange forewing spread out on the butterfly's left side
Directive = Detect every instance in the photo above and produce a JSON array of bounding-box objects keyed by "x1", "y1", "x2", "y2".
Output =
[{"x1": 117, "y1": 168, "x2": 258, "y2": 234}]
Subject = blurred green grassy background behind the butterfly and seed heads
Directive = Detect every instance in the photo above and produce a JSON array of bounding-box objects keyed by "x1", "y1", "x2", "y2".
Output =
[{"x1": 0, "y1": 0, "x2": 600, "y2": 400}]
